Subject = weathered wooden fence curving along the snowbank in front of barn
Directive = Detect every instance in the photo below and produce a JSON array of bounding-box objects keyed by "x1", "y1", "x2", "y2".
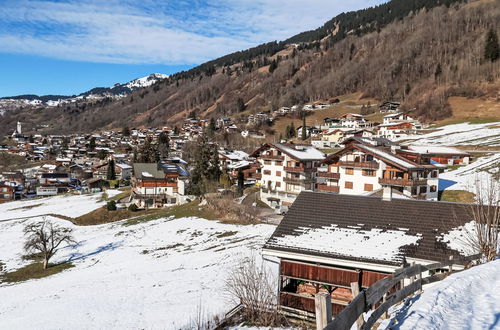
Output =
[{"x1": 316, "y1": 254, "x2": 482, "y2": 330}]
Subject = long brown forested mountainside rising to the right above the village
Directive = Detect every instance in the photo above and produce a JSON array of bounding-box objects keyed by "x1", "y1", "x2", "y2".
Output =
[{"x1": 0, "y1": 0, "x2": 500, "y2": 132}]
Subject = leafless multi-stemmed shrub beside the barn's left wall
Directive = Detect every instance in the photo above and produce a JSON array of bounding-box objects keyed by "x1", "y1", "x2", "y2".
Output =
[{"x1": 226, "y1": 256, "x2": 283, "y2": 326}]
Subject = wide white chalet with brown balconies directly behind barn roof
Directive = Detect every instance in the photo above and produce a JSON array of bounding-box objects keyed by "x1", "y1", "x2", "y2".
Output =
[{"x1": 316, "y1": 139, "x2": 441, "y2": 200}]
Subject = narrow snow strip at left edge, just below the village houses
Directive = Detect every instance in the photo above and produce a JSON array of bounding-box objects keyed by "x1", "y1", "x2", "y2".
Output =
[{"x1": 0, "y1": 189, "x2": 121, "y2": 221}]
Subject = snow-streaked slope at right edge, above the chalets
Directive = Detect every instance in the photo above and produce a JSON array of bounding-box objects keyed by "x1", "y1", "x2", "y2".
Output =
[{"x1": 402, "y1": 122, "x2": 500, "y2": 147}]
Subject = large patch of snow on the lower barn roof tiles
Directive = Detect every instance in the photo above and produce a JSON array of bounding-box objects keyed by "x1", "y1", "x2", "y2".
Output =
[{"x1": 268, "y1": 225, "x2": 421, "y2": 261}]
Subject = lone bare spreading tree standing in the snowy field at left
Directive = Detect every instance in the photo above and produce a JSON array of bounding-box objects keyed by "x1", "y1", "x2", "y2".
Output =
[{"x1": 24, "y1": 219, "x2": 74, "y2": 269}]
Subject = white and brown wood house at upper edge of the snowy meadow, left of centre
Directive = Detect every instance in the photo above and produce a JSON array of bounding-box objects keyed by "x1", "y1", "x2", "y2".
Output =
[{"x1": 130, "y1": 162, "x2": 189, "y2": 208}]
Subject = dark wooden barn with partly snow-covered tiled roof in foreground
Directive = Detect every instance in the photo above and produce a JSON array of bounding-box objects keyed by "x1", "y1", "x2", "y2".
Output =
[{"x1": 263, "y1": 192, "x2": 470, "y2": 317}]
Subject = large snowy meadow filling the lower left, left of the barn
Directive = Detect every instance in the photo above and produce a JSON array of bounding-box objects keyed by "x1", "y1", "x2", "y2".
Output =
[{"x1": 0, "y1": 214, "x2": 275, "y2": 329}]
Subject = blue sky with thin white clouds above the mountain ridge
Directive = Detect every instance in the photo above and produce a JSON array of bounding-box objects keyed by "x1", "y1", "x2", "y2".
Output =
[{"x1": 0, "y1": 0, "x2": 384, "y2": 96}]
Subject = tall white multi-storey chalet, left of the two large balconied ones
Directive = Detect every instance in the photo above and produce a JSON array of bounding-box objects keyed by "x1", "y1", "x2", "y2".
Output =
[{"x1": 251, "y1": 143, "x2": 325, "y2": 208}]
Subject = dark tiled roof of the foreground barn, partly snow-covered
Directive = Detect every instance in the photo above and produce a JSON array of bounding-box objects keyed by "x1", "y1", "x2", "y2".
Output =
[{"x1": 264, "y1": 191, "x2": 471, "y2": 265}]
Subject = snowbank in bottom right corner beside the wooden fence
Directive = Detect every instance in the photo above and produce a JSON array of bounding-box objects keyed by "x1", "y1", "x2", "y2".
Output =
[{"x1": 379, "y1": 259, "x2": 500, "y2": 330}]
